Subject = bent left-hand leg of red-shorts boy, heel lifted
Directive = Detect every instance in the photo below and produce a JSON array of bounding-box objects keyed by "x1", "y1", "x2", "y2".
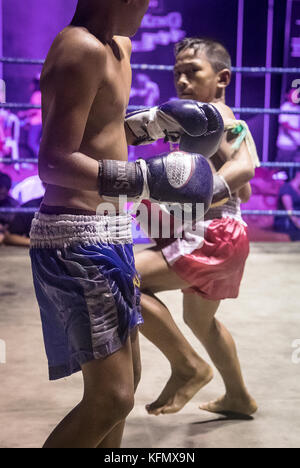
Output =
[{"x1": 136, "y1": 249, "x2": 213, "y2": 415}]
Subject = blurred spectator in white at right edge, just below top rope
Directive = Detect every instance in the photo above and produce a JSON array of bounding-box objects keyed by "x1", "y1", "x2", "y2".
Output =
[{"x1": 277, "y1": 89, "x2": 300, "y2": 162}]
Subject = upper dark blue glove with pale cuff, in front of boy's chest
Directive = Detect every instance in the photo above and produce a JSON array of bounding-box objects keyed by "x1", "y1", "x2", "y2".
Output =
[{"x1": 125, "y1": 99, "x2": 224, "y2": 146}]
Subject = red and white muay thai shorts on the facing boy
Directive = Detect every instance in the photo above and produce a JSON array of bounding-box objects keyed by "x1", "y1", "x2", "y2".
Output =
[{"x1": 150, "y1": 198, "x2": 250, "y2": 301}]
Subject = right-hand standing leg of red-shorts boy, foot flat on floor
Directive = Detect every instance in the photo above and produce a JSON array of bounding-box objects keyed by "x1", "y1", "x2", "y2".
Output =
[{"x1": 184, "y1": 294, "x2": 257, "y2": 416}]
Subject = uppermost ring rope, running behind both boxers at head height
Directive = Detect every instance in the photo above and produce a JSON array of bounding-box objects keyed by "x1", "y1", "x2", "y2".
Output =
[{"x1": 0, "y1": 57, "x2": 300, "y2": 74}]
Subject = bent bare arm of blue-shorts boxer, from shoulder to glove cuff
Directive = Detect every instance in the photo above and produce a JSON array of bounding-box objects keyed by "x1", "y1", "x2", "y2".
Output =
[{"x1": 39, "y1": 41, "x2": 106, "y2": 191}]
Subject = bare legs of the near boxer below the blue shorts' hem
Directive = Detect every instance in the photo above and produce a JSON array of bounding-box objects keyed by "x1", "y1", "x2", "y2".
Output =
[{"x1": 44, "y1": 339, "x2": 134, "y2": 448}]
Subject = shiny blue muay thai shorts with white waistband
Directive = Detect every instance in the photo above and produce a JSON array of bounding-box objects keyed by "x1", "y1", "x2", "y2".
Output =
[{"x1": 30, "y1": 212, "x2": 143, "y2": 380}]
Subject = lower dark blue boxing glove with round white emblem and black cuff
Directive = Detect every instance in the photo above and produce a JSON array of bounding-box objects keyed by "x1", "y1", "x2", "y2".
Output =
[{"x1": 99, "y1": 151, "x2": 213, "y2": 216}]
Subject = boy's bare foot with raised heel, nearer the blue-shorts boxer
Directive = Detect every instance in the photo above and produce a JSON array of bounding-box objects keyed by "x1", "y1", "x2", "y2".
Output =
[{"x1": 146, "y1": 364, "x2": 213, "y2": 416}]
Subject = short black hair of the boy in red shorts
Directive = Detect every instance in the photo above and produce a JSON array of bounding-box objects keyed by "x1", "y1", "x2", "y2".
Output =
[{"x1": 175, "y1": 37, "x2": 232, "y2": 73}]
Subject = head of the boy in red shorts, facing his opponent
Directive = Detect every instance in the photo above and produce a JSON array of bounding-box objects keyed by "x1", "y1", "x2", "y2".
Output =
[{"x1": 174, "y1": 38, "x2": 231, "y2": 102}]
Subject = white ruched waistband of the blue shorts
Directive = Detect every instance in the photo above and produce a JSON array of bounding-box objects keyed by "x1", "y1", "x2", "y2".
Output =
[{"x1": 30, "y1": 213, "x2": 133, "y2": 249}]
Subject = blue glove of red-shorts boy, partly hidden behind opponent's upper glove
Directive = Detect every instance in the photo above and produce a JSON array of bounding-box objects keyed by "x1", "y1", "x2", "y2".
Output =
[{"x1": 179, "y1": 103, "x2": 224, "y2": 158}]
